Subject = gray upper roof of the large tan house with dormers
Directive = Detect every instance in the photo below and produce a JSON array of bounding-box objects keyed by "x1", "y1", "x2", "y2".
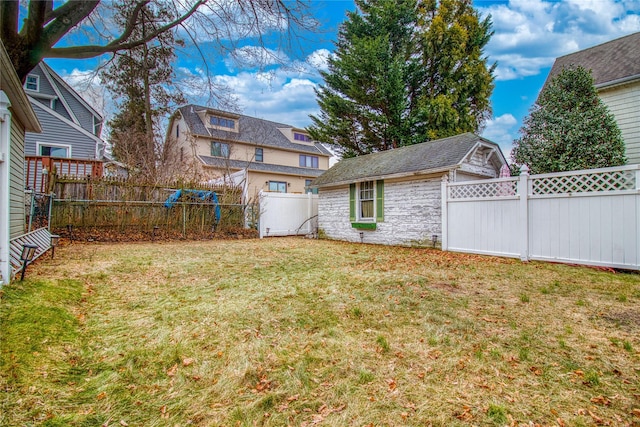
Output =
[{"x1": 178, "y1": 104, "x2": 331, "y2": 156}]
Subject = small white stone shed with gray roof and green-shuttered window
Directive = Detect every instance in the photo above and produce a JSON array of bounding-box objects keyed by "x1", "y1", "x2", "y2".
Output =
[{"x1": 313, "y1": 133, "x2": 506, "y2": 246}]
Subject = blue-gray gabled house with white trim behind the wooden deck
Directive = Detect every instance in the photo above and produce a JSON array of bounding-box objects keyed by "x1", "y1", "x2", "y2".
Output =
[{"x1": 24, "y1": 62, "x2": 104, "y2": 188}]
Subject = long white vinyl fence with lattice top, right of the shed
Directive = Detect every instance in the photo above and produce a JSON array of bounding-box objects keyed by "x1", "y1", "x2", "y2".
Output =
[{"x1": 442, "y1": 165, "x2": 640, "y2": 270}]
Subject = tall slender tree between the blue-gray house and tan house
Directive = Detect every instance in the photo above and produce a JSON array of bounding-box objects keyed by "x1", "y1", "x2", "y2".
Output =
[{"x1": 101, "y1": 1, "x2": 185, "y2": 179}]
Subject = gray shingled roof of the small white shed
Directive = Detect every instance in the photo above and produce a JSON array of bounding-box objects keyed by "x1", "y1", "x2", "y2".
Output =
[{"x1": 313, "y1": 133, "x2": 500, "y2": 187}]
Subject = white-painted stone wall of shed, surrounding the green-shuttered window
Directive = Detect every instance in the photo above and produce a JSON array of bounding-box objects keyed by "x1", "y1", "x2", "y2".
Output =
[{"x1": 318, "y1": 178, "x2": 442, "y2": 246}]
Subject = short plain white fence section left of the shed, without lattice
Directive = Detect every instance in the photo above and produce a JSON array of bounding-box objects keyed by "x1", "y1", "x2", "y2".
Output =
[{"x1": 259, "y1": 192, "x2": 318, "y2": 238}]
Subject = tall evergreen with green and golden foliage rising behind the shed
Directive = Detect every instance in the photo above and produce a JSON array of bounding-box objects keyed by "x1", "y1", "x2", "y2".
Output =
[{"x1": 309, "y1": 0, "x2": 493, "y2": 157}]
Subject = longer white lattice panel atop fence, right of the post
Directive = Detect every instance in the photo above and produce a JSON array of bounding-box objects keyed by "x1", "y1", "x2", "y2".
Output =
[{"x1": 532, "y1": 170, "x2": 636, "y2": 195}]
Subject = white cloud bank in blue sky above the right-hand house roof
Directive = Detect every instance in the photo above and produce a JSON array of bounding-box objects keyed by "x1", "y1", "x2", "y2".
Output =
[{"x1": 478, "y1": 0, "x2": 640, "y2": 80}]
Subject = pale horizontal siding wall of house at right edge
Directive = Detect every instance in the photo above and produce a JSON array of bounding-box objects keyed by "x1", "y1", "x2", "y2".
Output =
[{"x1": 599, "y1": 82, "x2": 640, "y2": 164}]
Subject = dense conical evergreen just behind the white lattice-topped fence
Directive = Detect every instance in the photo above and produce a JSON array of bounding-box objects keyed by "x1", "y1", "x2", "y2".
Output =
[{"x1": 511, "y1": 67, "x2": 626, "y2": 173}]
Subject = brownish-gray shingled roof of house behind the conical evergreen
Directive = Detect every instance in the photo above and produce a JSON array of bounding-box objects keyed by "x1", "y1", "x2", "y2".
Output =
[{"x1": 545, "y1": 32, "x2": 640, "y2": 86}]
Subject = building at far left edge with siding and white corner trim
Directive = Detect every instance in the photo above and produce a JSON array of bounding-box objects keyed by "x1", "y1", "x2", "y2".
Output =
[{"x1": 0, "y1": 40, "x2": 41, "y2": 284}]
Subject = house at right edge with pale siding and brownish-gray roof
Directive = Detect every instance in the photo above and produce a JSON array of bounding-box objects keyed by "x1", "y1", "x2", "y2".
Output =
[{"x1": 545, "y1": 32, "x2": 640, "y2": 164}]
